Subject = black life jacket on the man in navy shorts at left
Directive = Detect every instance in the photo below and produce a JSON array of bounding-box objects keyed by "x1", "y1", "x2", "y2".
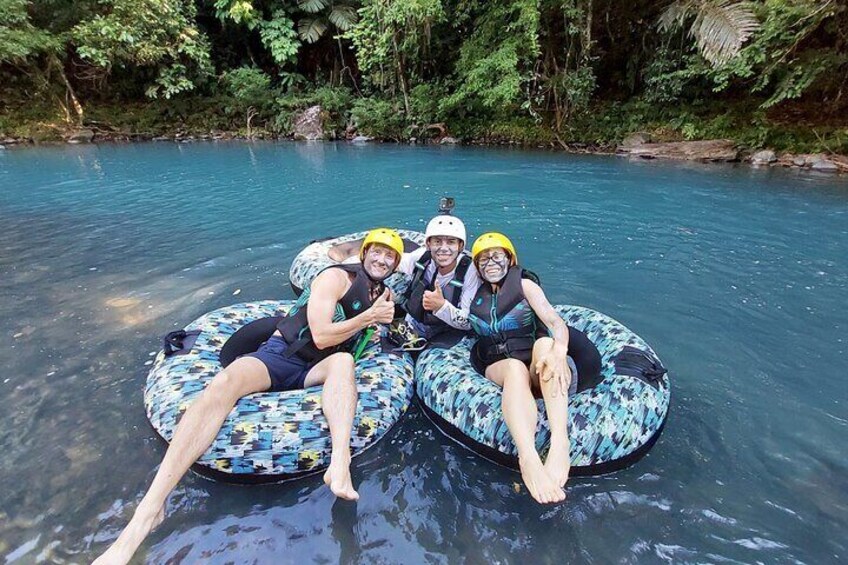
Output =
[{"x1": 277, "y1": 263, "x2": 385, "y2": 364}]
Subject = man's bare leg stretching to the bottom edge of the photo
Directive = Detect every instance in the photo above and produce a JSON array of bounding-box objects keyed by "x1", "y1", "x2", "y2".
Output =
[{"x1": 94, "y1": 357, "x2": 271, "y2": 565}]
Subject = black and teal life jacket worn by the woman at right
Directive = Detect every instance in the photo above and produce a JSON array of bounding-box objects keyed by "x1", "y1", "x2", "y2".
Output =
[{"x1": 468, "y1": 265, "x2": 547, "y2": 366}]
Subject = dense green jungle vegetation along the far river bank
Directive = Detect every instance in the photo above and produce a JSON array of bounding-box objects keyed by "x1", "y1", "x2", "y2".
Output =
[{"x1": 0, "y1": 0, "x2": 848, "y2": 153}]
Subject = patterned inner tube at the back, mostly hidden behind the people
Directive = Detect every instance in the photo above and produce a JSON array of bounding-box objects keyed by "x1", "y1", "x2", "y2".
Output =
[{"x1": 289, "y1": 230, "x2": 424, "y2": 296}]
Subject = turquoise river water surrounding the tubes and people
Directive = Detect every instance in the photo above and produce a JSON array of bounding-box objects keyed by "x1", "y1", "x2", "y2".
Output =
[{"x1": 0, "y1": 143, "x2": 848, "y2": 563}]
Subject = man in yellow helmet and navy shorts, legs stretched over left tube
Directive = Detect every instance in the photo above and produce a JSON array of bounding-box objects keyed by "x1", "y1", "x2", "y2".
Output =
[{"x1": 95, "y1": 228, "x2": 403, "y2": 563}]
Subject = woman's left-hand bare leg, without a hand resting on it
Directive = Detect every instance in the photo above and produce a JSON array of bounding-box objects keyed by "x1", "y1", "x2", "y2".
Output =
[{"x1": 486, "y1": 359, "x2": 565, "y2": 504}]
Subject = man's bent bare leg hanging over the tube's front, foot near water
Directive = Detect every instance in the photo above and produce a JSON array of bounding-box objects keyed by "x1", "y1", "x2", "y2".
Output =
[{"x1": 304, "y1": 353, "x2": 359, "y2": 500}]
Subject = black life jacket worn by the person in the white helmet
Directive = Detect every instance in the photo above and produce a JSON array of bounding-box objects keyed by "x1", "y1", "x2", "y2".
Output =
[{"x1": 404, "y1": 251, "x2": 471, "y2": 348}]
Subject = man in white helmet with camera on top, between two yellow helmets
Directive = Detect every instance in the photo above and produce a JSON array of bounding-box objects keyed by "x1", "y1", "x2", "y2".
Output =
[{"x1": 398, "y1": 198, "x2": 480, "y2": 347}]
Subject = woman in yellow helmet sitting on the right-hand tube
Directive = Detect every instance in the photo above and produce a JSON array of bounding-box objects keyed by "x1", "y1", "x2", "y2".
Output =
[{"x1": 469, "y1": 232, "x2": 576, "y2": 503}]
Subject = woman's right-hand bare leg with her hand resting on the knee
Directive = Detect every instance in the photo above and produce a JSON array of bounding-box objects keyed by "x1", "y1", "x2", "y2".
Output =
[{"x1": 530, "y1": 337, "x2": 571, "y2": 487}]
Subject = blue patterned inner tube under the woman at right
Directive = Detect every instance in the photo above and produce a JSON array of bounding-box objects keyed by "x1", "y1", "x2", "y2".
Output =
[{"x1": 415, "y1": 306, "x2": 671, "y2": 476}]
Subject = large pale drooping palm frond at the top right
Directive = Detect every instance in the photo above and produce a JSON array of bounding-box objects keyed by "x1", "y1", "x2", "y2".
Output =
[{"x1": 689, "y1": 0, "x2": 760, "y2": 67}]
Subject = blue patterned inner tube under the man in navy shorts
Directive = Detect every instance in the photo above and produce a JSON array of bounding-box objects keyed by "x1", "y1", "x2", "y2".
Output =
[{"x1": 144, "y1": 300, "x2": 413, "y2": 483}]
